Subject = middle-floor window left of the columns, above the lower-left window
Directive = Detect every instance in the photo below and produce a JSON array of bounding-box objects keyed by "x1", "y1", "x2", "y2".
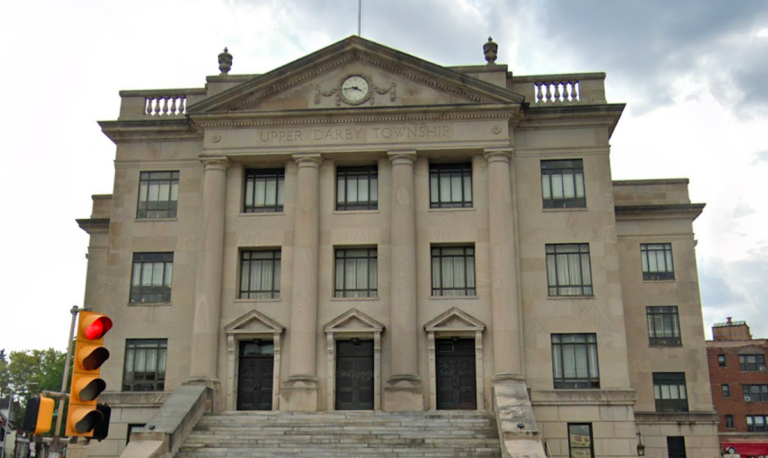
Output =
[{"x1": 131, "y1": 253, "x2": 173, "y2": 303}]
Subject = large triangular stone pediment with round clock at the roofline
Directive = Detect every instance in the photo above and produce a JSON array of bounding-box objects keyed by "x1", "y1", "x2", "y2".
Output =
[{"x1": 188, "y1": 36, "x2": 524, "y2": 117}]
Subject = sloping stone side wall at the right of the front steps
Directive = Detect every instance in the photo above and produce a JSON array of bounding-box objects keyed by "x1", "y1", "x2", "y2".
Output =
[{"x1": 493, "y1": 374, "x2": 547, "y2": 458}]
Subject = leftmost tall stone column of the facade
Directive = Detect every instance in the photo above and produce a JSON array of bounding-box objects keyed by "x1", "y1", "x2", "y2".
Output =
[{"x1": 189, "y1": 157, "x2": 229, "y2": 399}]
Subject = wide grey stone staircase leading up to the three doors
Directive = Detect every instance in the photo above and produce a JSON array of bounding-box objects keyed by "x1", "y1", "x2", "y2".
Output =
[{"x1": 176, "y1": 411, "x2": 501, "y2": 458}]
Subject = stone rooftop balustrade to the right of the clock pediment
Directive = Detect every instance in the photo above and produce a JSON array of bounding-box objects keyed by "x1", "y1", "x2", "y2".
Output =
[{"x1": 511, "y1": 73, "x2": 607, "y2": 107}]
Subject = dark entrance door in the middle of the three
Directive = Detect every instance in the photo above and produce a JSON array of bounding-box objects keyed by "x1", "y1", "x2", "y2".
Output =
[{"x1": 336, "y1": 339, "x2": 373, "y2": 410}]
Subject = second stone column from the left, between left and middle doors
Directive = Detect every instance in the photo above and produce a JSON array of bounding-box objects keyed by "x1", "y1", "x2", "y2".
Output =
[{"x1": 281, "y1": 154, "x2": 320, "y2": 411}]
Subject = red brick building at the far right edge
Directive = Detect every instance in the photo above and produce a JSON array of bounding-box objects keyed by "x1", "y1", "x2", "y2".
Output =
[{"x1": 707, "y1": 317, "x2": 768, "y2": 457}]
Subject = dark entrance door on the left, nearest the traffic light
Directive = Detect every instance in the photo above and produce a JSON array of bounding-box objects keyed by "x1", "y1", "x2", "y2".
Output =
[{"x1": 237, "y1": 340, "x2": 275, "y2": 410}]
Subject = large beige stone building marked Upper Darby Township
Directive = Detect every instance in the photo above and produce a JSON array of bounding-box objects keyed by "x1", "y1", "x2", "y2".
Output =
[{"x1": 73, "y1": 37, "x2": 719, "y2": 458}]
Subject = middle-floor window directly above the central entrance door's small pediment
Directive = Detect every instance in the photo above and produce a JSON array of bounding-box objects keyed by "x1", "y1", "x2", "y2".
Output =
[{"x1": 334, "y1": 248, "x2": 379, "y2": 297}]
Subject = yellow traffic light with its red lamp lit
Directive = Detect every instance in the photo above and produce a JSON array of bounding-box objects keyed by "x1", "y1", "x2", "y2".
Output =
[{"x1": 66, "y1": 311, "x2": 112, "y2": 437}]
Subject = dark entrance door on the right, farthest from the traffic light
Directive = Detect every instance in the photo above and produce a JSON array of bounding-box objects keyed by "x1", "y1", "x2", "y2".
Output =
[{"x1": 435, "y1": 339, "x2": 477, "y2": 410}]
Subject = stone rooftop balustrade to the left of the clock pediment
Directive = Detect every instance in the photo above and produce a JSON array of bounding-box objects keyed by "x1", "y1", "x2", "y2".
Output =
[{"x1": 119, "y1": 88, "x2": 206, "y2": 120}]
